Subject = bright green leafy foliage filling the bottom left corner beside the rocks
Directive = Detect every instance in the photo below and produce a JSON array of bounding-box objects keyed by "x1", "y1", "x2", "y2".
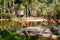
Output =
[{"x1": 0, "y1": 29, "x2": 28, "y2": 40}]
